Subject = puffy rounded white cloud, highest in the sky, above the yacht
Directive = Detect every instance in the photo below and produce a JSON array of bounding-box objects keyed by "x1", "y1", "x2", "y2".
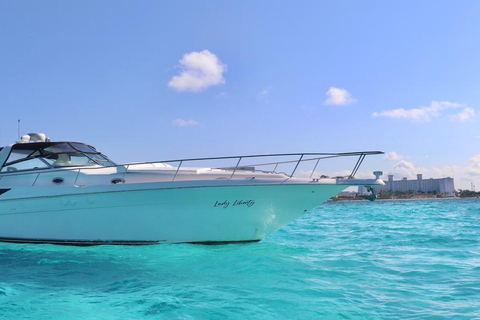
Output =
[{"x1": 168, "y1": 50, "x2": 227, "y2": 92}]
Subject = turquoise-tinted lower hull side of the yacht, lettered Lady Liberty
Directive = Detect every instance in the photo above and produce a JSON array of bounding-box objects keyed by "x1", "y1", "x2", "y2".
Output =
[{"x1": 0, "y1": 183, "x2": 347, "y2": 245}]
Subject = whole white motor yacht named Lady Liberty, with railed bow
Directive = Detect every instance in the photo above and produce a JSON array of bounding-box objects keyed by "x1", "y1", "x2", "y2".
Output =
[{"x1": 0, "y1": 133, "x2": 384, "y2": 245}]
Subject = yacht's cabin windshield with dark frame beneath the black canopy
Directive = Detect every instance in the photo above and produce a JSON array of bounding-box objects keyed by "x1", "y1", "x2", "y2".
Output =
[{"x1": 1, "y1": 142, "x2": 115, "y2": 172}]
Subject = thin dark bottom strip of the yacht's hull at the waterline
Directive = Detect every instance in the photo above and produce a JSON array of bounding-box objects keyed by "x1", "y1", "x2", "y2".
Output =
[{"x1": 0, "y1": 238, "x2": 260, "y2": 247}]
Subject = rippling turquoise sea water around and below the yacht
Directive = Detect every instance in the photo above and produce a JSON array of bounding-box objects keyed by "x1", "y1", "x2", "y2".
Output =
[{"x1": 0, "y1": 200, "x2": 480, "y2": 319}]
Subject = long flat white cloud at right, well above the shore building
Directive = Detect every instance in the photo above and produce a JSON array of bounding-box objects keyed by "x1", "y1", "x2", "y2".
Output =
[{"x1": 372, "y1": 101, "x2": 475, "y2": 122}]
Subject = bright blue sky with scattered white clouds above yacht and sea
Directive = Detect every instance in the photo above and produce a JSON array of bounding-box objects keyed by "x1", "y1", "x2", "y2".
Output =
[{"x1": 0, "y1": 0, "x2": 480, "y2": 191}]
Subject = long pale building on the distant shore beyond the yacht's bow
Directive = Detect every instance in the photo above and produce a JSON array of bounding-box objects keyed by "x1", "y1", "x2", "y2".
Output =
[{"x1": 358, "y1": 174, "x2": 455, "y2": 197}]
